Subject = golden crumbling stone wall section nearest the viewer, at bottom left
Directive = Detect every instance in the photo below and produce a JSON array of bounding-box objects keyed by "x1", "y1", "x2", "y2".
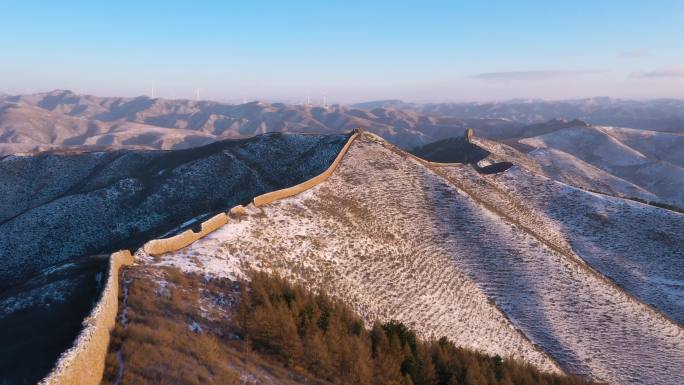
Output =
[{"x1": 39, "y1": 250, "x2": 134, "y2": 385}]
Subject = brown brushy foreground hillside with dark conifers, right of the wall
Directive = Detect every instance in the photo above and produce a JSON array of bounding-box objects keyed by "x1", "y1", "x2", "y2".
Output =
[{"x1": 102, "y1": 266, "x2": 592, "y2": 385}]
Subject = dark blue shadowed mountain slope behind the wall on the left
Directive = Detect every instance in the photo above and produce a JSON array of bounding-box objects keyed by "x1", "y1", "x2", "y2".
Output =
[{"x1": 0, "y1": 134, "x2": 347, "y2": 285}]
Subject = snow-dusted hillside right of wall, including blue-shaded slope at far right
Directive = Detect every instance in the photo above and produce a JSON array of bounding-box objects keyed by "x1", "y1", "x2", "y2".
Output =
[{"x1": 124, "y1": 134, "x2": 684, "y2": 384}]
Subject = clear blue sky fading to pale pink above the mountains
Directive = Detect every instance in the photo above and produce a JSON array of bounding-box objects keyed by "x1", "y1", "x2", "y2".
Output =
[{"x1": 0, "y1": 0, "x2": 684, "y2": 102}]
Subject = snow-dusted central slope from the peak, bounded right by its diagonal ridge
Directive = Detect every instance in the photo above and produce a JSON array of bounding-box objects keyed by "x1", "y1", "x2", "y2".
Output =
[{"x1": 160, "y1": 134, "x2": 684, "y2": 384}]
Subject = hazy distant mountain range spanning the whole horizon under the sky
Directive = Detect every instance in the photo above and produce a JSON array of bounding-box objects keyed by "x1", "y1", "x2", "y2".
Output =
[{"x1": 0, "y1": 90, "x2": 684, "y2": 156}]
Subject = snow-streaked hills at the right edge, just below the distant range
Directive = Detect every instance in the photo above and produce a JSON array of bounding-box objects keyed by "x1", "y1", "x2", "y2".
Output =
[{"x1": 520, "y1": 126, "x2": 684, "y2": 206}]
